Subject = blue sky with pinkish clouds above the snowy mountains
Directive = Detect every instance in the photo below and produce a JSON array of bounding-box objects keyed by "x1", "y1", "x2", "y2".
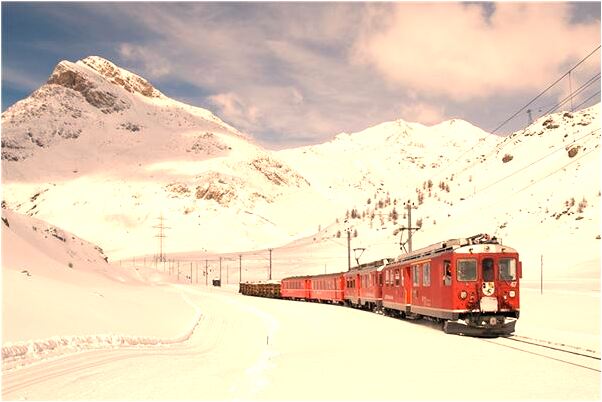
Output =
[{"x1": 1, "y1": 2, "x2": 600, "y2": 149}]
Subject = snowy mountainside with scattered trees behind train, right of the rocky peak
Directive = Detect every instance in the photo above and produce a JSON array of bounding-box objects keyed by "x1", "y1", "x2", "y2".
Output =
[{"x1": 279, "y1": 105, "x2": 600, "y2": 282}]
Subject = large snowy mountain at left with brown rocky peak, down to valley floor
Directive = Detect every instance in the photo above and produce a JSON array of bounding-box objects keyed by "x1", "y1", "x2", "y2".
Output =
[{"x1": 2, "y1": 57, "x2": 328, "y2": 257}]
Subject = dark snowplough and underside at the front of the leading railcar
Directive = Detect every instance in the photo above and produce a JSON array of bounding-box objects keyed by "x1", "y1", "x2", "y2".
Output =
[{"x1": 443, "y1": 315, "x2": 517, "y2": 337}]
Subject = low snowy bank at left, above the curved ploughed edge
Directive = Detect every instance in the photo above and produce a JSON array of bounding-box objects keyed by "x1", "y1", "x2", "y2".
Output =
[{"x1": 0, "y1": 208, "x2": 194, "y2": 350}]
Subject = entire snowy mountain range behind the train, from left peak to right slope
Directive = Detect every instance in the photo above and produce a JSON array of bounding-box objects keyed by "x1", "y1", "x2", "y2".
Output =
[{"x1": 2, "y1": 57, "x2": 600, "y2": 276}]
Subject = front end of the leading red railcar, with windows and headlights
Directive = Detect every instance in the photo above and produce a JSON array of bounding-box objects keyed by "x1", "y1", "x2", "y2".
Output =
[{"x1": 444, "y1": 243, "x2": 522, "y2": 336}]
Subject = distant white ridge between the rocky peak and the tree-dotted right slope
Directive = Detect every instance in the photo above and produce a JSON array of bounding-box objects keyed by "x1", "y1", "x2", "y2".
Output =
[{"x1": 278, "y1": 116, "x2": 500, "y2": 204}]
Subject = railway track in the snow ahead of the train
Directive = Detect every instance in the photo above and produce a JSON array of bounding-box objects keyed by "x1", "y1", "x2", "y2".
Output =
[{"x1": 483, "y1": 335, "x2": 601, "y2": 373}]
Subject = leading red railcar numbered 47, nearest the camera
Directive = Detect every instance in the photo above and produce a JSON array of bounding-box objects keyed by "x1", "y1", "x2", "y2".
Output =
[{"x1": 383, "y1": 234, "x2": 522, "y2": 335}]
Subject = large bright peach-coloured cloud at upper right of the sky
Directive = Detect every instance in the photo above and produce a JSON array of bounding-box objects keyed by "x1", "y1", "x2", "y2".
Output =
[{"x1": 351, "y1": 2, "x2": 600, "y2": 101}]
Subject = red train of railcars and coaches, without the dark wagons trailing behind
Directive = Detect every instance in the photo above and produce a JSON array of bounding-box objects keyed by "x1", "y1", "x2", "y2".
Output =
[{"x1": 246, "y1": 234, "x2": 522, "y2": 336}]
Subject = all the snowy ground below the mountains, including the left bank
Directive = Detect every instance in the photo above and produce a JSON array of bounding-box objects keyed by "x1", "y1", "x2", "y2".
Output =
[{"x1": 2, "y1": 211, "x2": 601, "y2": 400}]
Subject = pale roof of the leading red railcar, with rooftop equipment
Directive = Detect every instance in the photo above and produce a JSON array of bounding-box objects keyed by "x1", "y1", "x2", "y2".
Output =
[{"x1": 395, "y1": 233, "x2": 516, "y2": 262}]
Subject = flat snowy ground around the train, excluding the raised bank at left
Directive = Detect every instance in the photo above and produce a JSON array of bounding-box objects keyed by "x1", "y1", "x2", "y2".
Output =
[{"x1": 3, "y1": 272, "x2": 600, "y2": 400}]
